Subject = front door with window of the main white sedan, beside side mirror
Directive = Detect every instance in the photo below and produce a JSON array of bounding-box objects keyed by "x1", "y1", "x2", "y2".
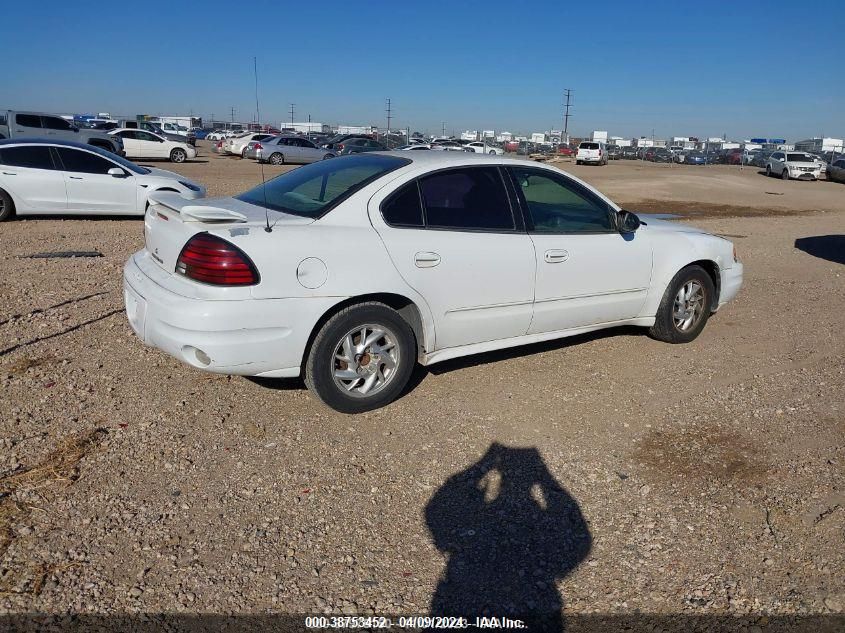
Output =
[{"x1": 510, "y1": 167, "x2": 652, "y2": 334}]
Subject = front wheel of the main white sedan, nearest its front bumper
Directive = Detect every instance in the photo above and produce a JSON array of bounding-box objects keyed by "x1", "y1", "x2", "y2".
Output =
[{"x1": 649, "y1": 266, "x2": 716, "y2": 343}]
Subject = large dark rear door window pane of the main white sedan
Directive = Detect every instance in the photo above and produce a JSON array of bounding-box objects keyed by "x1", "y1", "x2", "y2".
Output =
[{"x1": 420, "y1": 167, "x2": 515, "y2": 231}]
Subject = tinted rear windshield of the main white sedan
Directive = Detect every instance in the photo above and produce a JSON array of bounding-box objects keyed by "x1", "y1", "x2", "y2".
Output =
[{"x1": 235, "y1": 154, "x2": 410, "y2": 218}]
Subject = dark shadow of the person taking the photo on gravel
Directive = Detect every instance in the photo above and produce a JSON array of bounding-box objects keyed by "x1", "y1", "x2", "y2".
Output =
[{"x1": 425, "y1": 443, "x2": 592, "y2": 631}]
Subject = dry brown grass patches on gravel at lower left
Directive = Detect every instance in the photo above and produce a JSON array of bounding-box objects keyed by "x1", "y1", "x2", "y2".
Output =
[{"x1": 0, "y1": 428, "x2": 107, "y2": 595}]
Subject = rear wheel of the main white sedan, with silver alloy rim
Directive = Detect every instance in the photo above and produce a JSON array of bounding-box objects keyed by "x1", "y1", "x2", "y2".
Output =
[{"x1": 305, "y1": 302, "x2": 416, "y2": 413}]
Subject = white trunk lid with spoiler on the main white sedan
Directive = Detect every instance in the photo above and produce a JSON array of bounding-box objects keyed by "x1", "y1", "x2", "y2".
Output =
[{"x1": 144, "y1": 191, "x2": 314, "y2": 273}]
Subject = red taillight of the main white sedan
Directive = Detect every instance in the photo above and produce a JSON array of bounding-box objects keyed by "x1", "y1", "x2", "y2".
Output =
[{"x1": 176, "y1": 233, "x2": 259, "y2": 286}]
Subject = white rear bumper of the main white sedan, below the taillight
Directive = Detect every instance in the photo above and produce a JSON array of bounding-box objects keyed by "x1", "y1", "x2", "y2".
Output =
[{"x1": 123, "y1": 251, "x2": 337, "y2": 377}]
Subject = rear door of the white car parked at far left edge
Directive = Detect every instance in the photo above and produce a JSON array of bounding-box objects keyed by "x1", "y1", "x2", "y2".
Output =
[{"x1": 0, "y1": 145, "x2": 67, "y2": 213}]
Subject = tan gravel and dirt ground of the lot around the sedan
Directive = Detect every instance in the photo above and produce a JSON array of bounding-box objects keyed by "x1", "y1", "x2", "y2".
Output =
[{"x1": 0, "y1": 144, "x2": 845, "y2": 626}]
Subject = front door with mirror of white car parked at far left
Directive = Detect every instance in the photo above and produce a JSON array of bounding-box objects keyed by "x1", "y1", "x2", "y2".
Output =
[{"x1": 56, "y1": 147, "x2": 138, "y2": 215}]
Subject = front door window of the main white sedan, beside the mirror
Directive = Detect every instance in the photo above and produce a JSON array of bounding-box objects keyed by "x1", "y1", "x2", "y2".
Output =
[{"x1": 512, "y1": 167, "x2": 613, "y2": 233}]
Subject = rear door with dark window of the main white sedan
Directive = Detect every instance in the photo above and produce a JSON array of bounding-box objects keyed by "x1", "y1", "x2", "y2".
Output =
[{"x1": 369, "y1": 166, "x2": 534, "y2": 351}]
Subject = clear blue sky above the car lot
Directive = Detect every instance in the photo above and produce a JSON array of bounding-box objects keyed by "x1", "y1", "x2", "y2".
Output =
[{"x1": 6, "y1": 0, "x2": 845, "y2": 140}]
